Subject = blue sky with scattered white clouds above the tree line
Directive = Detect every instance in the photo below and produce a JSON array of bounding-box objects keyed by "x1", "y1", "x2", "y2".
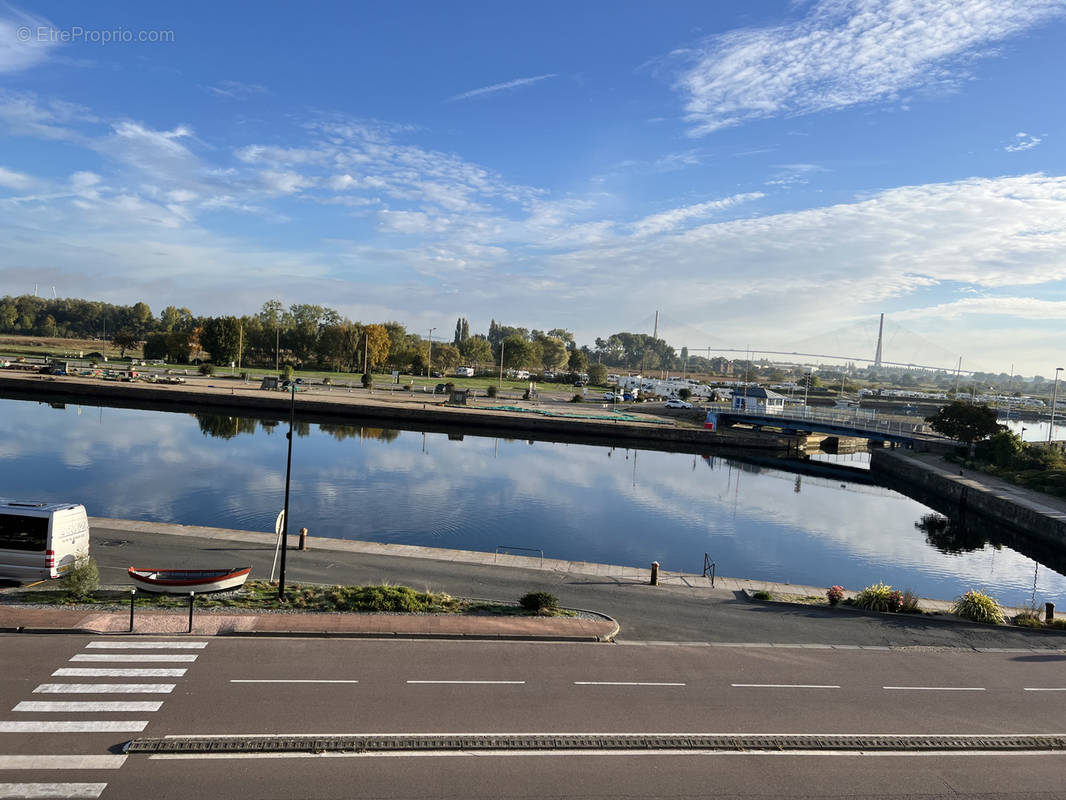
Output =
[{"x1": 0, "y1": 0, "x2": 1066, "y2": 377}]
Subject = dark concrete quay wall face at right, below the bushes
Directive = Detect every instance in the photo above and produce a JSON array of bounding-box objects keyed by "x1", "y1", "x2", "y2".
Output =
[{"x1": 870, "y1": 450, "x2": 1066, "y2": 545}]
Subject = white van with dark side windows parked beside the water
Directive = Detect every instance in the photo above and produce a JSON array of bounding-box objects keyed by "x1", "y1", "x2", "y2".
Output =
[{"x1": 0, "y1": 498, "x2": 88, "y2": 581}]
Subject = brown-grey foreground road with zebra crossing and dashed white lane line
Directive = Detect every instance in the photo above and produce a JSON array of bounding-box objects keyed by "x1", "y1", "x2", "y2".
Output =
[{"x1": 0, "y1": 635, "x2": 1066, "y2": 800}]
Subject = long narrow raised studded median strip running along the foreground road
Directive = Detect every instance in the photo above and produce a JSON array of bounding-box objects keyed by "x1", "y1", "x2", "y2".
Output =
[{"x1": 126, "y1": 734, "x2": 1066, "y2": 753}]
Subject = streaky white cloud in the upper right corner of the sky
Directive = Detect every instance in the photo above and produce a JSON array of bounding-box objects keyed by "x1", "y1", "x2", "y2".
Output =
[{"x1": 676, "y1": 0, "x2": 1066, "y2": 135}]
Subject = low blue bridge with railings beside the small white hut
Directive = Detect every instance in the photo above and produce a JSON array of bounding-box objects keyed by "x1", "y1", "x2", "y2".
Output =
[{"x1": 709, "y1": 405, "x2": 951, "y2": 447}]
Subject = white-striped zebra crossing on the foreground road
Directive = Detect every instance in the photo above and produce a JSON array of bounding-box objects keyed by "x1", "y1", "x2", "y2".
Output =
[{"x1": 0, "y1": 639, "x2": 208, "y2": 800}]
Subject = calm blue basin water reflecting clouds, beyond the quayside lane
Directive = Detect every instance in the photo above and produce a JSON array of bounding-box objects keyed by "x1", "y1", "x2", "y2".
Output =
[{"x1": 0, "y1": 400, "x2": 1066, "y2": 604}]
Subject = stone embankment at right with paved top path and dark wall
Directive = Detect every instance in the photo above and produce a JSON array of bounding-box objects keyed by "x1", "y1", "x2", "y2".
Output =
[{"x1": 870, "y1": 450, "x2": 1066, "y2": 545}]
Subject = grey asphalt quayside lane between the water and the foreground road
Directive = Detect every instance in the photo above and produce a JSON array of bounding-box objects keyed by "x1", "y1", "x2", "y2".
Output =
[{"x1": 92, "y1": 528, "x2": 1066, "y2": 647}]
